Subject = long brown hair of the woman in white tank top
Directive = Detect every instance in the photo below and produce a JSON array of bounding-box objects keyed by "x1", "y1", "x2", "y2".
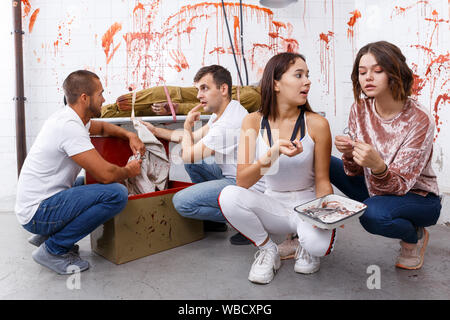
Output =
[{"x1": 259, "y1": 52, "x2": 313, "y2": 120}]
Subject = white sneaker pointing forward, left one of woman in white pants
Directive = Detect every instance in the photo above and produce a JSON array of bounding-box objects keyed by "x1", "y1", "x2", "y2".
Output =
[{"x1": 248, "y1": 249, "x2": 281, "y2": 284}]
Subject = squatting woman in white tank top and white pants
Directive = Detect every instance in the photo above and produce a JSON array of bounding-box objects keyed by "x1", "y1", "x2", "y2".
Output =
[{"x1": 219, "y1": 52, "x2": 336, "y2": 283}]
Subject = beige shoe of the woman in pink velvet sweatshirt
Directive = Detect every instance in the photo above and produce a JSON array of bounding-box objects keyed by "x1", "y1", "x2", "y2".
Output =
[{"x1": 395, "y1": 228, "x2": 430, "y2": 270}]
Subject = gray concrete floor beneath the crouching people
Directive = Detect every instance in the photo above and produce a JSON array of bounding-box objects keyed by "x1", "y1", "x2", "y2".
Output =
[{"x1": 0, "y1": 213, "x2": 450, "y2": 300}]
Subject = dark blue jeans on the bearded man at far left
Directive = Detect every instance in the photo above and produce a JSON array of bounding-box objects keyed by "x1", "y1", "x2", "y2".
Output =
[{"x1": 23, "y1": 179, "x2": 128, "y2": 255}]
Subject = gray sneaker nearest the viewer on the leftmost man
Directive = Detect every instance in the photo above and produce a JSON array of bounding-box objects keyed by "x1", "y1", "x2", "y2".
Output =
[{"x1": 31, "y1": 243, "x2": 89, "y2": 274}]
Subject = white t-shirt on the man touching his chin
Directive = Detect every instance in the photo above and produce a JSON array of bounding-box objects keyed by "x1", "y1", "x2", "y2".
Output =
[{"x1": 201, "y1": 100, "x2": 265, "y2": 192}]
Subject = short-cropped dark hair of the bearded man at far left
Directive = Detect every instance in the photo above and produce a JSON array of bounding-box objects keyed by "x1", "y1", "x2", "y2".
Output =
[{"x1": 63, "y1": 70, "x2": 100, "y2": 104}]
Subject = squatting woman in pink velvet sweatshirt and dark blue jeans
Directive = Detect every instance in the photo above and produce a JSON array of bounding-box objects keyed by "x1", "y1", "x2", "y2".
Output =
[{"x1": 330, "y1": 41, "x2": 441, "y2": 269}]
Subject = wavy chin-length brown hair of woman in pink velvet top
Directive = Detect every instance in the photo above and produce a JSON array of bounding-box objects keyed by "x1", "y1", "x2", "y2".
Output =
[{"x1": 352, "y1": 41, "x2": 414, "y2": 103}]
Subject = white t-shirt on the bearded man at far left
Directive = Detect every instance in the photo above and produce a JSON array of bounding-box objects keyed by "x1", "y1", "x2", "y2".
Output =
[{"x1": 15, "y1": 106, "x2": 94, "y2": 225}]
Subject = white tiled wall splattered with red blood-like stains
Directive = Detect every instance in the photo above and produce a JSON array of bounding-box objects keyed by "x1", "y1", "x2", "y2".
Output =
[{"x1": 0, "y1": 0, "x2": 450, "y2": 218}]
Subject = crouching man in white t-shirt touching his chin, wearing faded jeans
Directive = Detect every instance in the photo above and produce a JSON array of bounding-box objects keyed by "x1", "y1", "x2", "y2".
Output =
[{"x1": 143, "y1": 65, "x2": 264, "y2": 244}]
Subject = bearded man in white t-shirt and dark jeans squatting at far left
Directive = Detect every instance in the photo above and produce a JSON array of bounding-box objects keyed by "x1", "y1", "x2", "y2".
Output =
[{"x1": 15, "y1": 70, "x2": 145, "y2": 274}]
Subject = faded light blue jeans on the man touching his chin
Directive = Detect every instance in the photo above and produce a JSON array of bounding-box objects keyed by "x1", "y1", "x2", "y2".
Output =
[{"x1": 172, "y1": 161, "x2": 236, "y2": 223}]
